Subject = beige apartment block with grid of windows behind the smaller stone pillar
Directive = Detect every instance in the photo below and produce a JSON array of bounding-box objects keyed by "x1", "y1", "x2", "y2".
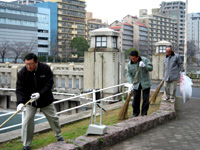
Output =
[{"x1": 138, "y1": 11, "x2": 177, "y2": 59}]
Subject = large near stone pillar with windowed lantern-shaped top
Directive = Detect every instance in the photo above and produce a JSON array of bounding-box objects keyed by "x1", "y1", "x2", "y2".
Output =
[{"x1": 84, "y1": 28, "x2": 125, "y2": 96}]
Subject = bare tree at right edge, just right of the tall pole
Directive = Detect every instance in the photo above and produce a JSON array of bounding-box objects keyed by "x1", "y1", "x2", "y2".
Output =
[{"x1": 187, "y1": 40, "x2": 198, "y2": 64}]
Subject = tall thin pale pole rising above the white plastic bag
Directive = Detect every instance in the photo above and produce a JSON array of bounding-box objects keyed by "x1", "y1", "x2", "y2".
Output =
[{"x1": 184, "y1": 0, "x2": 188, "y2": 73}]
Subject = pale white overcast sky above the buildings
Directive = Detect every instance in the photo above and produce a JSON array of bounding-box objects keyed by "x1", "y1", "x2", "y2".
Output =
[{"x1": 0, "y1": 0, "x2": 200, "y2": 24}]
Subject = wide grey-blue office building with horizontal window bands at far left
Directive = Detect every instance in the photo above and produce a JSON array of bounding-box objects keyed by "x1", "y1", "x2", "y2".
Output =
[{"x1": 0, "y1": 2, "x2": 38, "y2": 62}]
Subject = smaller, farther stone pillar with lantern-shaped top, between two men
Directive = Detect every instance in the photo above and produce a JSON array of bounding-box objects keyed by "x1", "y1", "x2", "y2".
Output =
[{"x1": 152, "y1": 41, "x2": 171, "y2": 80}]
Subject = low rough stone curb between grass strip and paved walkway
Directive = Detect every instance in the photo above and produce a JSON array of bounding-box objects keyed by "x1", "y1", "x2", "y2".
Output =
[{"x1": 39, "y1": 96, "x2": 176, "y2": 150}]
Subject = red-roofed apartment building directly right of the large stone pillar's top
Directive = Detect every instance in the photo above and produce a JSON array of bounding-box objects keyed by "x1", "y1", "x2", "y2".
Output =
[{"x1": 109, "y1": 20, "x2": 134, "y2": 52}]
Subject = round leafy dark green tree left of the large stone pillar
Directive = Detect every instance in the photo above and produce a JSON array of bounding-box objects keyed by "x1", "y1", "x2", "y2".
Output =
[{"x1": 70, "y1": 37, "x2": 90, "y2": 60}]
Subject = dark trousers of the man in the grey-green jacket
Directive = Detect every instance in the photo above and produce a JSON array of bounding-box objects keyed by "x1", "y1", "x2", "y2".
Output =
[{"x1": 132, "y1": 84, "x2": 150, "y2": 116}]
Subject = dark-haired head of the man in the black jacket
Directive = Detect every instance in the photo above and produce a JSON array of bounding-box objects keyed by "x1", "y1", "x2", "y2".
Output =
[{"x1": 24, "y1": 53, "x2": 38, "y2": 72}]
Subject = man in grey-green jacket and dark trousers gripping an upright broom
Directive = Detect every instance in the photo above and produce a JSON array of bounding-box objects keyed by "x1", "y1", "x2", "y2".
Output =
[{"x1": 127, "y1": 51, "x2": 153, "y2": 117}]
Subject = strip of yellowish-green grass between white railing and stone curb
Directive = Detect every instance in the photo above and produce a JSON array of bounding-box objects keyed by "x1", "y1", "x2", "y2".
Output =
[{"x1": 0, "y1": 95, "x2": 161, "y2": 150}]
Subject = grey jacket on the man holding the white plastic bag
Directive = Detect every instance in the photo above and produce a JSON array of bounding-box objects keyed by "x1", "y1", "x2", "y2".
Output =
[{"x1": 164, "y1": 53, "x2": 185, "y2": 81}]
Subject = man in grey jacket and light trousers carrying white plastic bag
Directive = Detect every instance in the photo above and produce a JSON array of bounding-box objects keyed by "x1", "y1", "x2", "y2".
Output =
[{"x1": 164, "y1": 46, "x2": 185, "y2": 103}]
